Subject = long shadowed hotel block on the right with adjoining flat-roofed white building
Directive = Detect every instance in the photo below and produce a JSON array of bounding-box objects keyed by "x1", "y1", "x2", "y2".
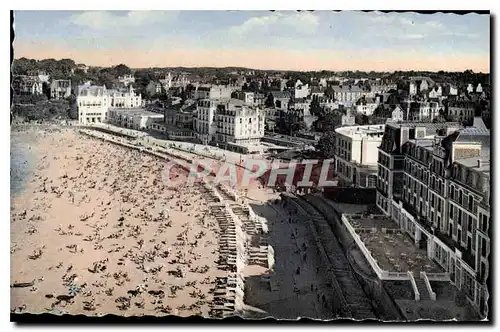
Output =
[{"x1": 334, "y1": 118, "x2": 491, "y2": 315}]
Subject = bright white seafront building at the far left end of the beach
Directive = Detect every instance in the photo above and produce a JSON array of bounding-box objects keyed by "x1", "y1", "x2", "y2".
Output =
[{"x1": 76, "y1": 85, "x2": 142, "y2": 124}]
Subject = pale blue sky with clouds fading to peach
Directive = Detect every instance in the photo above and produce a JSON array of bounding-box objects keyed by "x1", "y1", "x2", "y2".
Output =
[{"x1": 14, "y1": 11, "x2": 490, "y2": 72}]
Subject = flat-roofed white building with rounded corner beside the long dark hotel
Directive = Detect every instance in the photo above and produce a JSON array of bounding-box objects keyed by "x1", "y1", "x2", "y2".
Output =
[{"x1": 335, "y1": 125, "x2": 384, "y2": 188}]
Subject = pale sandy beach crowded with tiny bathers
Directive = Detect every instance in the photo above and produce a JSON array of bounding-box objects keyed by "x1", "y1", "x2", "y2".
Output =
[{"x1": 11, "y1": 129, "x2": 225, "y2": 316}]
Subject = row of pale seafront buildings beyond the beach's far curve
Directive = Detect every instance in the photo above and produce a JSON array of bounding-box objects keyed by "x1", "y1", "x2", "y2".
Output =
[{"x1": 77, "y1": 81, "x2": 265, "y2": 151}]
